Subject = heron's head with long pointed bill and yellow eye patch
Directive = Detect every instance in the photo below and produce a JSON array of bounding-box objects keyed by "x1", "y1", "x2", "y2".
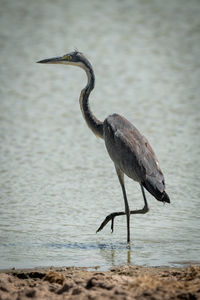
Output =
[{"x1": 38, "y1": 51, "x2": 90, "y2": 68}]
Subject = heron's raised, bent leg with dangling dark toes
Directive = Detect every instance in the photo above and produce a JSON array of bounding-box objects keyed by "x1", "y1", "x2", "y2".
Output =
[{"x1": 96, "y1": 185, "x2": 149, "y2": 232}]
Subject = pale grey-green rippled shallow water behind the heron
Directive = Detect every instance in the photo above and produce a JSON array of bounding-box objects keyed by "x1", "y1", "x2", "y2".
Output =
[{"x1": 0, "y1": 0, "x2": 200, "y2": 269}]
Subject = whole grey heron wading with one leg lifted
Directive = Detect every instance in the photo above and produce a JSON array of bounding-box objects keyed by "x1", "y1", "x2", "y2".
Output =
[{"x1": 38, "y1": 50, "x2": 170, "y2": 246}]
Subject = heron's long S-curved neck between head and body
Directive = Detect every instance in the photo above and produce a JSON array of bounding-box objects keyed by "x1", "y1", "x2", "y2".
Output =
[{"x1": 79, "y1": 62, "x2": 103, "y2": 139}]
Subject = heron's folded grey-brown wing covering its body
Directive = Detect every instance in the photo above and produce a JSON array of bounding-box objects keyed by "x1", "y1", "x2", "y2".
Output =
[{"x1": 104, "y1": 114, "x2": 164, "y2": 192}]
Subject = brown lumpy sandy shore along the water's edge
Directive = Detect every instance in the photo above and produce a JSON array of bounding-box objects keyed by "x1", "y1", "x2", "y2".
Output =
[{"x1": 0, "y1": 266, "x2": 200, "y2": 300}]
